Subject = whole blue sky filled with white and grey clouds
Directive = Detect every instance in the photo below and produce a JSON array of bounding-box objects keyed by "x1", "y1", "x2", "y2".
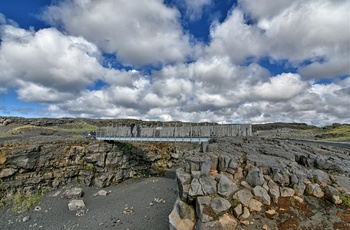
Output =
[{"x1": 0, "y1": 0, "x2": 350, "y2": 126}]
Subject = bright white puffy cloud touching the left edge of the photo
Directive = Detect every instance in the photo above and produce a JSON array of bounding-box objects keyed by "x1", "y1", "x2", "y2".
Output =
[{"x1": 0, "y1": 25, "x2": 103, "y2": 102}]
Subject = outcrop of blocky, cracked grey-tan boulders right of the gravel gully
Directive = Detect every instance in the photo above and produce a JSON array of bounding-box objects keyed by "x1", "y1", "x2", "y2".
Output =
[{"x1": 170, "y1": 138, "x2": 350, "y2": 230}]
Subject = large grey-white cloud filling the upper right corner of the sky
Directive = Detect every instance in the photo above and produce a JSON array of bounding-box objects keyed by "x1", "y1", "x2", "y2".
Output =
[{"x1": 207, "y1": 0, "x2": 350, "y2": 78}]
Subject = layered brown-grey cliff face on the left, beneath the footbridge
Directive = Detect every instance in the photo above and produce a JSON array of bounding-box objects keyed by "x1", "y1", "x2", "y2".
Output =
[{"x1": 0, "y1": 140, "x2": 199, "y2": 201}]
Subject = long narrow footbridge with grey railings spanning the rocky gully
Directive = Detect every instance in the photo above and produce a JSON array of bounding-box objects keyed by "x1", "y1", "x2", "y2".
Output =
[{"x1": 96, "y1": 123, "x2": 253, "y2": 142}]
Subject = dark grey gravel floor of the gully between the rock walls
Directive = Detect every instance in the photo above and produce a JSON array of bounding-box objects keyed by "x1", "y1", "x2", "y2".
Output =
[{"x1": 0, "y1": 177, "x2": 177, "y2": 230}]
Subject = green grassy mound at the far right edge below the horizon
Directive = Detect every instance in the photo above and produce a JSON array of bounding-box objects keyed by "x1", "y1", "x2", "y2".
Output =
[{"x1": 315, "y1": 124, "x2": 350, "y2": 141}]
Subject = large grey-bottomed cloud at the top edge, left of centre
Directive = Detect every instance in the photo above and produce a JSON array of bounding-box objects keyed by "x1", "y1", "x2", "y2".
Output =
[{"x1": 43, "y1": 0, "x2": 196, "y2": 65}]
